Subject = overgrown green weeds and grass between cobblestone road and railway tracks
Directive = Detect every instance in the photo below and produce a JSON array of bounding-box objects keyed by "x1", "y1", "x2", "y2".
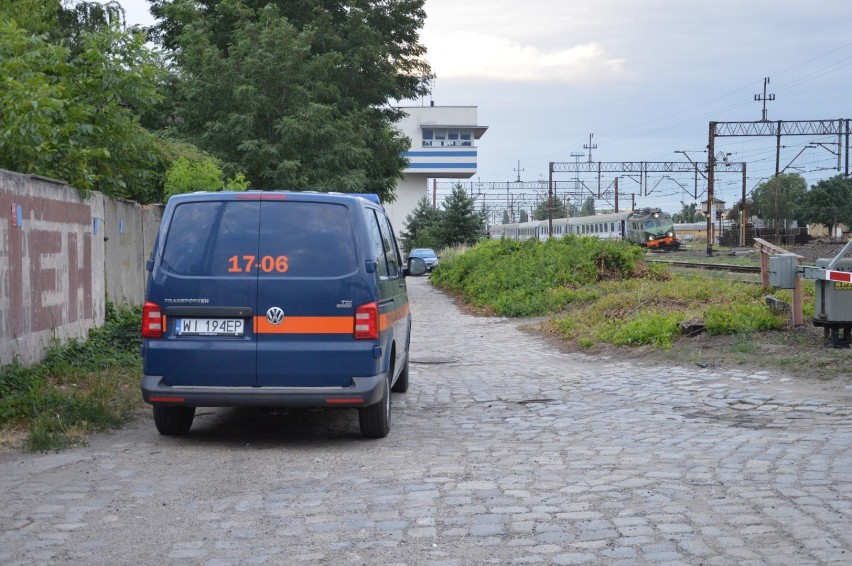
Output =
[{"x1": 431, "y1": 235, "x2": 792, "y2": 349}]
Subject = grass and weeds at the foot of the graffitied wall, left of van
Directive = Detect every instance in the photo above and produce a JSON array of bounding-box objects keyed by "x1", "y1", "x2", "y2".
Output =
[{"x1": 0, "y1": 304, "x2": 142, "y2": 451}]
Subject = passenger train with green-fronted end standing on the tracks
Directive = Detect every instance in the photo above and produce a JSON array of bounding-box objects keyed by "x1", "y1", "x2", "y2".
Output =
[{"x1": 489, "y1": 208, "x2": 680, "y2": 250}]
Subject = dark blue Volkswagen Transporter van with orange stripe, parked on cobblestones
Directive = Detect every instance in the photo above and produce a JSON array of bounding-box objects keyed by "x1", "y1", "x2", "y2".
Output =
[{"x1": 141, "y1": 191, "x2": 426, "y2": 438}]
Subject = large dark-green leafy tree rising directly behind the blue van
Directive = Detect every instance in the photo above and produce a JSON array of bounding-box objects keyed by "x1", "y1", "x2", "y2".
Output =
[{"x1": 146, "y1": 0, "x2": 431, "y2": 202}]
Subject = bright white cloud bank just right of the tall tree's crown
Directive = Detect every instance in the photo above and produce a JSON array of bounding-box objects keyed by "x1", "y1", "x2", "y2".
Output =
[{"x1": 422, "y1": 31, "x2": 627, "y2": 84}]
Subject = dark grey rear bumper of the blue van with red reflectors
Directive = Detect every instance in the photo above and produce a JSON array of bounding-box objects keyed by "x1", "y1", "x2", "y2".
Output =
[{"x1": 141, "y1": 374, "x2": 386, "y2": 407}]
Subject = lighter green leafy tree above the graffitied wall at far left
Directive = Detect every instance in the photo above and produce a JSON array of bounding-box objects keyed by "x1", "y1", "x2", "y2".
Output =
[{"x1": 0, "y1": 21, "x2": 162, "y2": 200}]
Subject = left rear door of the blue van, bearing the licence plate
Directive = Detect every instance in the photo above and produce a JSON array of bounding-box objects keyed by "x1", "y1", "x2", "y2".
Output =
[{"x1": 144, "y1": 195, "x2": 260, "y2": 387}]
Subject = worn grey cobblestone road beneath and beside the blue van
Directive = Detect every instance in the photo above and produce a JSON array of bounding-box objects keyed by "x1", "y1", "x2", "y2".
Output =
[{"x1": 0, "y1": 278, "x2": 852, "y2": 565}]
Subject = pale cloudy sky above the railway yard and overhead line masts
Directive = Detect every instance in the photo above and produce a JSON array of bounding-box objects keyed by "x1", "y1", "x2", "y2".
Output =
[{"x1": 115, "y1": 0, "x2": 852, "y2": 212}]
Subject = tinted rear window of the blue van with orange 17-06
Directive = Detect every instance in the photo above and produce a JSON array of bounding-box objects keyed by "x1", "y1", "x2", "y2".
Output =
[{"x1": 162, "y1": 201, "x2": 356, "y2": 277}]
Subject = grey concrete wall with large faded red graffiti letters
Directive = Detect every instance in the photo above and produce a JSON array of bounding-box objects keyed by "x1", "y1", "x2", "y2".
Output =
[{"x1": 0, "y1": 170, "x2": 162, "y2": 366}]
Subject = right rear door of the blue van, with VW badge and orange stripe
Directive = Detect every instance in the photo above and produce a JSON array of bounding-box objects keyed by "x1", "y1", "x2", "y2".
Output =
[{"x1": 255, "y1": 200, "x2": 378, "y2": 387}]
